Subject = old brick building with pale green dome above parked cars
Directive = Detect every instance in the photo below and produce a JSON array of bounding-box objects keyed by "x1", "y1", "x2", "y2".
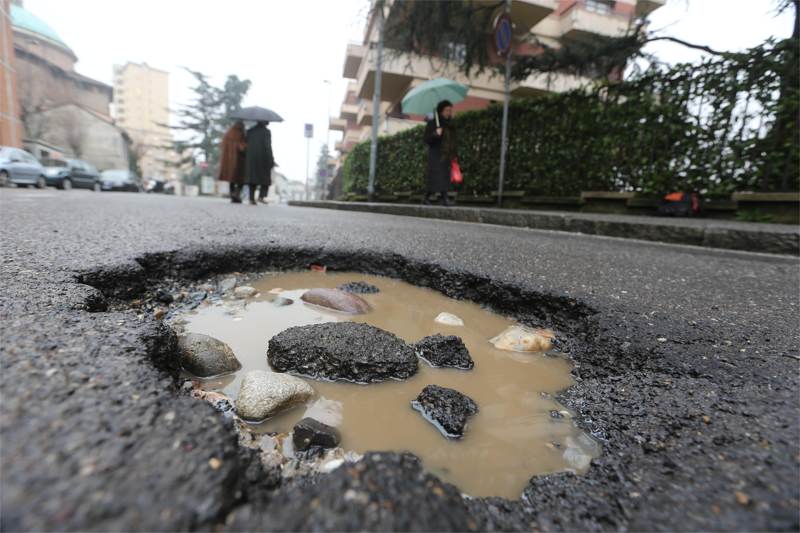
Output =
[{"x1": 10, "y1": 0, "x2": 129, "y2": 170}]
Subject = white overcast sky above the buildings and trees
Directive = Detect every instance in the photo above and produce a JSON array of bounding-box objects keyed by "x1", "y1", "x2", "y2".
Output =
[{"x1": 24, "y1": 0, "x2": 792, "y2": 180}]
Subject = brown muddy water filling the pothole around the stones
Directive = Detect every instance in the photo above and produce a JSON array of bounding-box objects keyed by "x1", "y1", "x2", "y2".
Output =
[{"x1": 175, "y1": 272, "x2": 600, "y2": 499}]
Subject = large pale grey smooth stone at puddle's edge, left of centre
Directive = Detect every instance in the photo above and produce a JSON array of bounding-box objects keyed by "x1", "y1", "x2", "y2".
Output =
[{"x1": 236, "y1": 370, "x2": 314, "y2": 422}]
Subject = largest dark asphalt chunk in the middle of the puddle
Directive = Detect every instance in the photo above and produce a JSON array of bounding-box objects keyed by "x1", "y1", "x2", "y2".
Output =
[{"x1": 267, "y1": 322, "x2": 417, "y2": 383}]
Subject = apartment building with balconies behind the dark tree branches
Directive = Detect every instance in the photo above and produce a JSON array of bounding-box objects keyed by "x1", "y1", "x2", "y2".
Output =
[{"x1": 330, "y1": 0, "x2": 666, "y2": 155}]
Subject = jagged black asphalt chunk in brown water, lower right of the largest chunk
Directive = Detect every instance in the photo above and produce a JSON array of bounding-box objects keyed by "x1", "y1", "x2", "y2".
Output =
[{"x1": 411, "y1": 385, "x2": 478, "y2": 439}]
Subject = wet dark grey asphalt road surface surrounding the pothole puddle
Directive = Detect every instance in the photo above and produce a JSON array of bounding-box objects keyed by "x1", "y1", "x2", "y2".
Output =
[{"x1": 0, "y1": 189, "x2": 800, "y2": 531}]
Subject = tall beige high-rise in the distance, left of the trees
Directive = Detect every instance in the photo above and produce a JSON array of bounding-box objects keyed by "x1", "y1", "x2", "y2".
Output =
[{"x1": 114, "y1": 63, "x2": 175, "y2": 179}]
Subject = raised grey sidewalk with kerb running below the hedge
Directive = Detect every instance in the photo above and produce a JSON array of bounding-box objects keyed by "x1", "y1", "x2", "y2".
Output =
[{"x1": 289, "y1": 201, "x2": 800, "y2": 255}]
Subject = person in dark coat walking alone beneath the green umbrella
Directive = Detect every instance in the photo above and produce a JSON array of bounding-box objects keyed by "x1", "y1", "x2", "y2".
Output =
[{"x1": 422, "y1": 100, "x2": 456, "y2": 205}]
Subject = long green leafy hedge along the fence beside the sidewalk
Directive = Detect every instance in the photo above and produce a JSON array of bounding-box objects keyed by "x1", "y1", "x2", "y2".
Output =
[{"x1": 344, "y1": 41, "x2": 800, "y2": 196}]
